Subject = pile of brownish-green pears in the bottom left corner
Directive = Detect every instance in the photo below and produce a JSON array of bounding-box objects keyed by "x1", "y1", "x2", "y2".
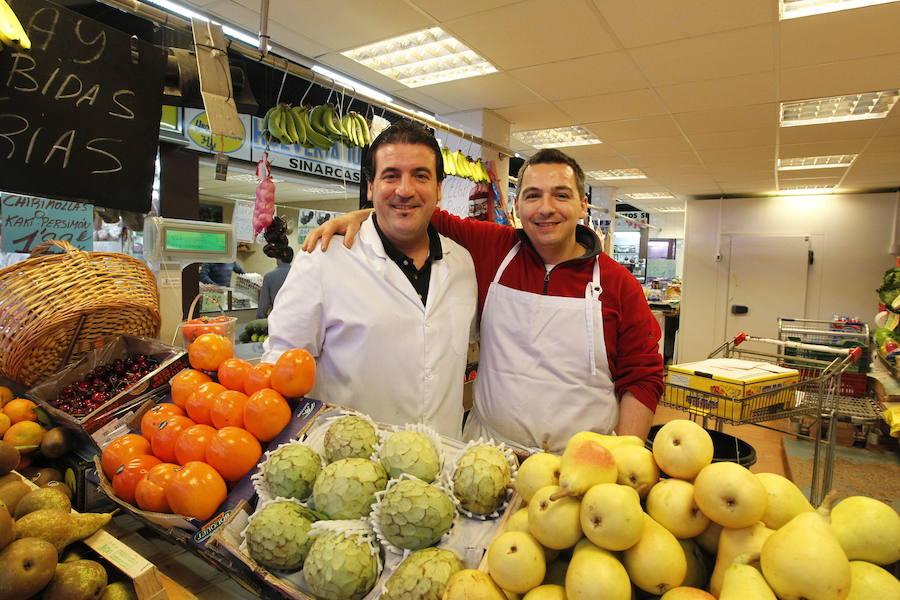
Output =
[{"x1": 0, "y1": 471, "x2": 137, "y2": 600}]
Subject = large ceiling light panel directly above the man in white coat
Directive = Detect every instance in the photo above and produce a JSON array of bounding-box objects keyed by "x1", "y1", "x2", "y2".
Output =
[{"x1": 342, "y1": 27, "x2": 497, "y2": 88}]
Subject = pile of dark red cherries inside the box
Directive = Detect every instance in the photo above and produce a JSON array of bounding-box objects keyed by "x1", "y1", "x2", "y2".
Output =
[{"x1": 50, "y1": 354, "x2": 159, "y2": 417}]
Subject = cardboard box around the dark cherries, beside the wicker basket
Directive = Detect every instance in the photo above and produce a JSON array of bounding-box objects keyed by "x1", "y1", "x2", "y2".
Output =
[{"x1": 26, "y1": 335, "x2": 189, "y2": 447}]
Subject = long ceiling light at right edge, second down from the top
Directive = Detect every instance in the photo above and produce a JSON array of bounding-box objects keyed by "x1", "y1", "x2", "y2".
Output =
[{"x1": 781, "y1": 90, "x2": 900, "y2": 127}]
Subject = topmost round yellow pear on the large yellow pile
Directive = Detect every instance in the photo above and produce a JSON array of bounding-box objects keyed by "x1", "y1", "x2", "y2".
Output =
[{"x1": 653, "y1": 419, "x2": 713, "y2": 480}]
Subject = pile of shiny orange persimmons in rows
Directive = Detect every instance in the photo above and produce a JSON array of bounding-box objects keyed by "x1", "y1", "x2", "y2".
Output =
[{"x1": 101, "y1": 333, "x2": 316, "y2": 520}]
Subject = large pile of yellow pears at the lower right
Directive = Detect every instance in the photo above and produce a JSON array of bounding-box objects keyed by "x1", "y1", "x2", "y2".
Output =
[{"x1": 464, "y1": 420, "x2": 900, "y2": 600}]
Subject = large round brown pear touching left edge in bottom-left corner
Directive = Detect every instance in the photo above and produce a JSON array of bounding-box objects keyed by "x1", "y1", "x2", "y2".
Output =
[{"x1": 0, "y1": 538, "x2": 56, "y2": 600}]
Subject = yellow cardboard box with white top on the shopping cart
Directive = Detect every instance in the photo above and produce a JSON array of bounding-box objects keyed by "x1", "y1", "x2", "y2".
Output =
[{"x1": 665, "y1": 358, "x2": 800, "y2": 421}]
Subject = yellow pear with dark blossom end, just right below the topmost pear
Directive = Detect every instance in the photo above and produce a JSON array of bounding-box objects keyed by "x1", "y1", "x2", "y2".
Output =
[{"x1": 694, "y1": 462, "x2": 768, "y2": 528}]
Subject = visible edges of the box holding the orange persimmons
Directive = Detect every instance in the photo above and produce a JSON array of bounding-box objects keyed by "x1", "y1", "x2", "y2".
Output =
[{"x1": 94, "y1": 398, "x2": 323, "y2": 547}]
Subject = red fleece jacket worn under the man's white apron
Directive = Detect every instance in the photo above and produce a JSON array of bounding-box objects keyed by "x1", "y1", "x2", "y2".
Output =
[{"x1": 431, "y1": 209, "x2": 663, "y2": 411}]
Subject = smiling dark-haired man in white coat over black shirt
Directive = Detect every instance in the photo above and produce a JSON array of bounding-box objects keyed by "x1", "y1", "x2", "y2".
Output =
[{"x1": 262, "y1": 121, "x2": 477, "y2": 438}]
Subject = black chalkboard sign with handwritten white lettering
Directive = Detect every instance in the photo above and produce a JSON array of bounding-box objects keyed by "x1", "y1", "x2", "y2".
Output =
[{"x1": 0, "y1": 0, "x2": 165, "y2": 212}]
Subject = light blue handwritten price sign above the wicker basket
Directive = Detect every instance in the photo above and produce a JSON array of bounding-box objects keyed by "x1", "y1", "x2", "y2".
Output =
[{"x1": 0, "y1": 194, "x2": 94, "y2": 252}]
